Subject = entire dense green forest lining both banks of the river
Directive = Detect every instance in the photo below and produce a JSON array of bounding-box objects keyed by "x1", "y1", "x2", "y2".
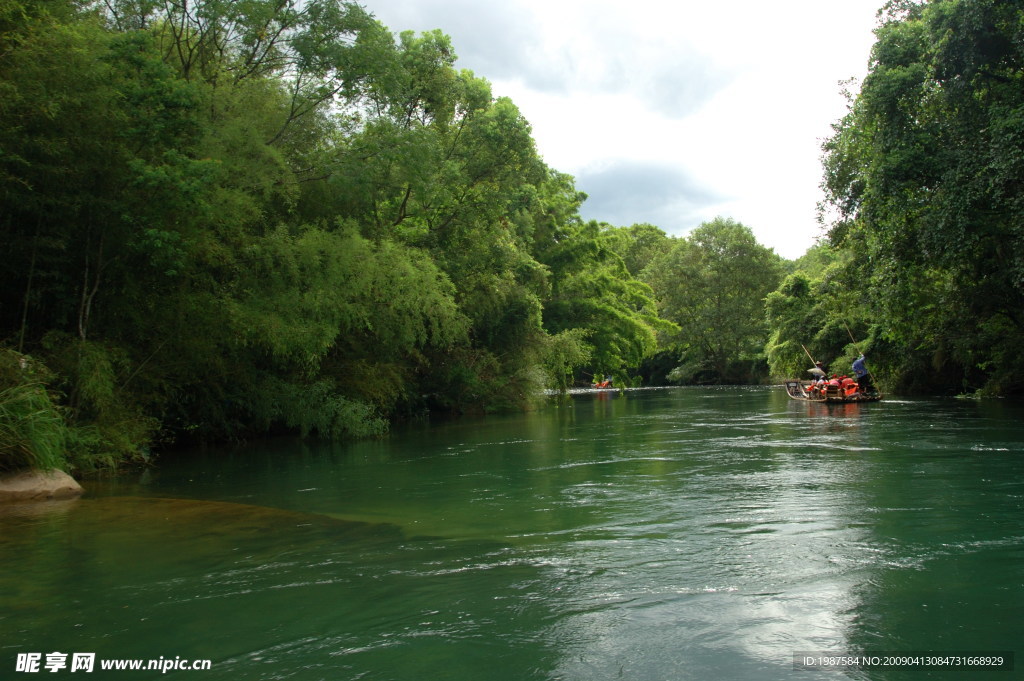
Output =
[{"x1": 0, "y1": 0, "x2": 1024, "y2": 469}]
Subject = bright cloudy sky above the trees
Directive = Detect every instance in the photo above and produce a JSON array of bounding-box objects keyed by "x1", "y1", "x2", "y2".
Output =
[{"x1": 359, "y1": 0, "x2": 884, "y2": 259}]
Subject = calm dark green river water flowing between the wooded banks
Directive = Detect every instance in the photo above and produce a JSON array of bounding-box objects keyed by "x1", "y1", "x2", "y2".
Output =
[{"x1": 0, "y1": 387, "x2": 1024, "y2": 681}]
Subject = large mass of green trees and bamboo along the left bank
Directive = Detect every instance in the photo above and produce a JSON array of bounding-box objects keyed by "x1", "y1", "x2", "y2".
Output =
[{"x1": 0, "y1": 0, "x2": 684, "y2": 468}]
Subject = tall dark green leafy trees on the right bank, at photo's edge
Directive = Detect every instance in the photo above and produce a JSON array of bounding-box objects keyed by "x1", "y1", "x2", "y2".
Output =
[{"x1": 824, "y1": 0, "x2": 1024, "y2": 392}]
